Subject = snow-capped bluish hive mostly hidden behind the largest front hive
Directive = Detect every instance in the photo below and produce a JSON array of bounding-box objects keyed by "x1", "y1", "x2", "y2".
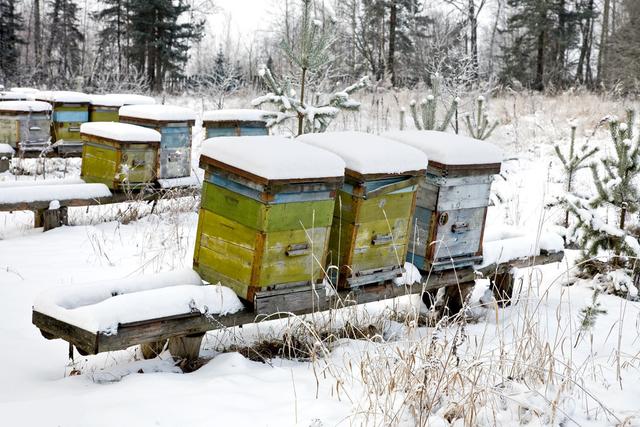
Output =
[{"x1": 202, "y1": 109, "x2": 275, "y2": 138}]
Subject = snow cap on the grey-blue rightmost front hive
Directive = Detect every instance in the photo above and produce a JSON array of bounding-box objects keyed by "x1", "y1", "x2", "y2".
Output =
[{"x1": 382, "y1": 130, "x2": 502, "y2": 165}]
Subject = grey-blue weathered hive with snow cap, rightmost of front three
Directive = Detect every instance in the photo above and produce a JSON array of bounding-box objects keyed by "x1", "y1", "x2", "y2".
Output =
[{"x1": 384, "y1": 131, "x2": 502, "y2": 271}]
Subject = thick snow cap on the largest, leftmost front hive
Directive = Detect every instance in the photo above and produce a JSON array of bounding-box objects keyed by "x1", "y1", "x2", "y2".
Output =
[{"x1": 202, "y1": 136, "x2": 345, "y2": 180}]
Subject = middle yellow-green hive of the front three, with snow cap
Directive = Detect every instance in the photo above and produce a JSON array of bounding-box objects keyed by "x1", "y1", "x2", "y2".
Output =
[{"x1": 297, "y1": 132, "x2": 427, "y2": 288}]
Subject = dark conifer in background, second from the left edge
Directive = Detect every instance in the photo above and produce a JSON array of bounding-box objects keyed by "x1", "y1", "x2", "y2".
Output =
[{"x1": 47, "y1": 0, "x2": 84, "y2": 85}]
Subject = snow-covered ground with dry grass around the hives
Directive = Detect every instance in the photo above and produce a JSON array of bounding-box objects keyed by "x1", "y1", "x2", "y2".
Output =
[{"x1": 0, "y1": 92, "x2": 640, "y2": 427}]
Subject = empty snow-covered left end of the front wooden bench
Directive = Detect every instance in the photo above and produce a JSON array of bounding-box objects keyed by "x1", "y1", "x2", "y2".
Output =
[{"x1": 33, "y1": 270, "x2": 244, "y2": 359}]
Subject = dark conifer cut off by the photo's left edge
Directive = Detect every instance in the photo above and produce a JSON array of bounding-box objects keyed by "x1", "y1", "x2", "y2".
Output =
[{"x1": 0, "y1": 0, "x2": 23, "y2": 80}]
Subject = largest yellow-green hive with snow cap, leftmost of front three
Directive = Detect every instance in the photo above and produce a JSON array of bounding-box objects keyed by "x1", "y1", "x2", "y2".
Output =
[{"x1": 194, "y1": 136, "x2": 344, "y2": 313}]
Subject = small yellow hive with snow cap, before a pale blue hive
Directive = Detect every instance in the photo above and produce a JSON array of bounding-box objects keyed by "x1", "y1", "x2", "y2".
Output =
[{"x1": 80, "y1": 122, "x2": 160, "y2": 190}]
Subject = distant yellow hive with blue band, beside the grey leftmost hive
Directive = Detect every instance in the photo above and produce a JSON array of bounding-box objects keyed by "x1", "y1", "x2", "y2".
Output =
[{"x1": 35, "y1": 91, "x2": 89, "y2": 155}]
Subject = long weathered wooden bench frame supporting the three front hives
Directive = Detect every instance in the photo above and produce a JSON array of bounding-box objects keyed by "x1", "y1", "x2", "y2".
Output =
[{"x1": 32, "y1": 252, "x2": 564, "y2": 359}]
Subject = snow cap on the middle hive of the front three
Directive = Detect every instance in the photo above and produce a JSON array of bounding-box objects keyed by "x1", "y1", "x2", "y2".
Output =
[{"x1": 297, "y1": 132, "x2": 428, "y2": 174}]
